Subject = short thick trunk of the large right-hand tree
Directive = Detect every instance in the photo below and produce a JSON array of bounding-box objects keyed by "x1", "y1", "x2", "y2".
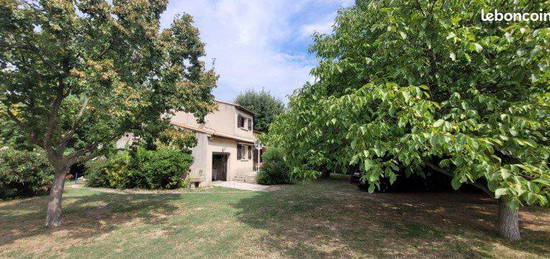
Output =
[{"x1": 498, "y1": 198, "x2": 521, "y2": 240}]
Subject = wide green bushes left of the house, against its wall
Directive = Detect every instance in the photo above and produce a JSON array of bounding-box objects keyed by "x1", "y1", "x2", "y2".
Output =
[{"x1": 87, "y1": 146, "x2": 193, "y2": 189}]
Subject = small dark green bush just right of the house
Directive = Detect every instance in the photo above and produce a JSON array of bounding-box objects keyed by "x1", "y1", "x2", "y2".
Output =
[{"x1": 256, "y1": 148, "x2": 291, "y2": 185}]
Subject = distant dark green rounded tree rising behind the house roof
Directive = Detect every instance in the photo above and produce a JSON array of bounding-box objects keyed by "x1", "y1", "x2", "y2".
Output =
[{"x1": 234, "y1": 89, "x2": 285, "y2": 132}]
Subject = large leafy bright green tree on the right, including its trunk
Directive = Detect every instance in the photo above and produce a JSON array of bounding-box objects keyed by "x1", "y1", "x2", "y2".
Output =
[{"x1": 269, "y1": 0, "x2": 550, "y2": 239}]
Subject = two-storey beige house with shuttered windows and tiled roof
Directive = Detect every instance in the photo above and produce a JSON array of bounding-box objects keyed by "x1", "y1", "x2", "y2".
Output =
[{"x1": 170, "y1": 101, "x2": 261, "y2": 186}]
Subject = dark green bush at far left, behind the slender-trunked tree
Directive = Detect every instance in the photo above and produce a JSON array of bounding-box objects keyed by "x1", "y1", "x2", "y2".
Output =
[{"x1": 0, "y1": 149, "x2": 54, "y2": 199}]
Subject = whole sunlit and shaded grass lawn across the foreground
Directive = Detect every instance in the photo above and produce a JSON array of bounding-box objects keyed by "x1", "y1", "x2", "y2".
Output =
[{"x1": 0, "y1": 178, "x2": 550, "y2": 258}]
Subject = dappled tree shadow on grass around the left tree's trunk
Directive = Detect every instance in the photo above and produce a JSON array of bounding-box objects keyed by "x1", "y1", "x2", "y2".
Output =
[{"x1": 0, "y1": 193, "x2": 184, "y2": 247}]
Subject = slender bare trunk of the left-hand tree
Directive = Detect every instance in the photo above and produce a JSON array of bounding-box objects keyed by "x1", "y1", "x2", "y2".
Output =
[{"x1": 46, "y1": 167, "x2": 67, "y2": 227}]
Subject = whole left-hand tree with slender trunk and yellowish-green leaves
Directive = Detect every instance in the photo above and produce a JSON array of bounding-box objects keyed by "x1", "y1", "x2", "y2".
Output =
[{"x1": 0, "y1": 0, "x2": 217, "y2": 226}]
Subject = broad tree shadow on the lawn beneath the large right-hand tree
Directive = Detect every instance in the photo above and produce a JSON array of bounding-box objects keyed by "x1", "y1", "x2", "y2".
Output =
[{"x1": 233, "y1": 179, "x2": 550, "y2": 258}]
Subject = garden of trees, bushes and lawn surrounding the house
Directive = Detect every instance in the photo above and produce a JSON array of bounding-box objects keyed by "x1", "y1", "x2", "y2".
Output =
[{"x1": 0, "y1": 0, "x2": 550, "y2": 258}]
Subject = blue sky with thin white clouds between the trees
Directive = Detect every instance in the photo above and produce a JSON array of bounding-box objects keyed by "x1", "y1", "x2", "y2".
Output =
[{"x1": 162, "y1": 0, "x2": 354, "y2": 102}]
